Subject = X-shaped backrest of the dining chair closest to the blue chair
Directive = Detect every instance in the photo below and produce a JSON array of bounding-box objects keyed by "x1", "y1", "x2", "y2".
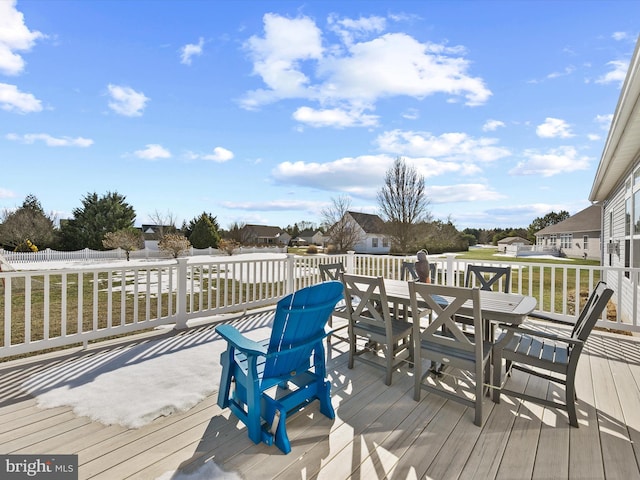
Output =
[{"x1": 342, "y1": 273, "x2": 391, "y2": 333}]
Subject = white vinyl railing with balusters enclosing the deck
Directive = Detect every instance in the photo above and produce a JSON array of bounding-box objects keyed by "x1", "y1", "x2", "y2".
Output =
[{"x1": 0, "y1": 253, "x2": 640, "y2": 358}]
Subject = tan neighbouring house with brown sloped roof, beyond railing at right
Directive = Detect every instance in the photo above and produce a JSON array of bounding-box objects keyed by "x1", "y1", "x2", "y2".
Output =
[{"x1": 535, "y1": 205, "x2": 602, "y2": 260}]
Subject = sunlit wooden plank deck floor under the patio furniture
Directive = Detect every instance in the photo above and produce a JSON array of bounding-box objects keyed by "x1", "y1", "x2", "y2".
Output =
[{"x1": 0, "y1": 312, "x2": 640, "y2": 480}]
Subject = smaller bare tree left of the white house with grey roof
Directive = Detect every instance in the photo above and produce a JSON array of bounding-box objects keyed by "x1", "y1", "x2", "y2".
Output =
[{"x1": 320, "y1": 195, "x2": 363, "y2": 253}]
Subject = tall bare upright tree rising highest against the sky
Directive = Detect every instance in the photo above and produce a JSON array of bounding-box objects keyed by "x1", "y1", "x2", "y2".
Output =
[{"x1": 378, "y1": 158, "x2": 431, "y2": 253}]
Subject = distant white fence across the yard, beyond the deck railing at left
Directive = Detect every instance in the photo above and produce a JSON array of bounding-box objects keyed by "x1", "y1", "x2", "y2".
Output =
[{"x1": 0, "y1": 247, "x2": 287, "y2": 263}]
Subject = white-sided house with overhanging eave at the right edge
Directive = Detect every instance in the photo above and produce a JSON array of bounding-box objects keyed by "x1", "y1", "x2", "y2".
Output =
[{"x1": 589, "y1": 35, "x2": 640, "y2": 321}]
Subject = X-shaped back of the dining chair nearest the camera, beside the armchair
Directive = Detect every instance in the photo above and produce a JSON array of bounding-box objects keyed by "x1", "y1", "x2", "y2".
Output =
[{"x1": 409, "y1": 282, "x2": 484, "y2": 358}]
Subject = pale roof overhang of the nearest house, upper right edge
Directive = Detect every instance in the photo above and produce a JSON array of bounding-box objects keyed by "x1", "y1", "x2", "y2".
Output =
[{"x1": 589, "y1": 37, "x2": 640, "y2": 202}]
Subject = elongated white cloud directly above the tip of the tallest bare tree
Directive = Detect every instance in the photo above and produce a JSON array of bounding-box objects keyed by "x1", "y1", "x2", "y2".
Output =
[{"x1": 376, "y1": 130, "x2": 511, "y2": 163}]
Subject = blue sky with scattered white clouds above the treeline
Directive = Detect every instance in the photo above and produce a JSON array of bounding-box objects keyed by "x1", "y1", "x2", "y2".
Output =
[{"x1": 0, "y1": 0, "x2": 640, "y2": 229}]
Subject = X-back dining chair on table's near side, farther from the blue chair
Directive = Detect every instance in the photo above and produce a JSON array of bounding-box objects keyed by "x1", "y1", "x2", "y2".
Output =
[{"x1": 409, "y1": 282, "x2": 491, "y2": 426}]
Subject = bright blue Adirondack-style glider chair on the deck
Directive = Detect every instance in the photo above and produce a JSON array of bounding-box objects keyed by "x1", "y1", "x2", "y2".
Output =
[{"x1": 216, "y1": 281, "x2": 343, "y2": 453}]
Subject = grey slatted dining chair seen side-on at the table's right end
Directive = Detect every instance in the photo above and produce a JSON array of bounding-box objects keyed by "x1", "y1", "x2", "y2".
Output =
[{"x1": 493, "y1": 282, "x2": 613, "y2": 427}]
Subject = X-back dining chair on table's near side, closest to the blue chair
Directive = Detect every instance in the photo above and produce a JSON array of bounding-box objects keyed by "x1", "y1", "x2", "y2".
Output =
[{"x1": 342, "y1": 273, "x2": 413, "y2": 385}]
